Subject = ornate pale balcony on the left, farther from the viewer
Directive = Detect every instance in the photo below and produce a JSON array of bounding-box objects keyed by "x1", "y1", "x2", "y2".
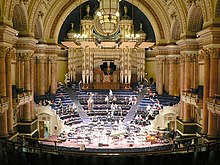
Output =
[{"x1": 12, "y1": 91, "x2": 33, "y2": 109}]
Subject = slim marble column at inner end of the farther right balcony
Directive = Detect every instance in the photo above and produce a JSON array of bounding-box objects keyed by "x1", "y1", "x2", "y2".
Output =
[{"x1": 180, "y1": 56, "x2": 185, "y2": 119}]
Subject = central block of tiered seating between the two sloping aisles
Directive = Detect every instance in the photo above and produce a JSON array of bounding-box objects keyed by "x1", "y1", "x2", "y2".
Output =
[{"x1": 77, "y1": 90, "x2": 137, "y2": 122}]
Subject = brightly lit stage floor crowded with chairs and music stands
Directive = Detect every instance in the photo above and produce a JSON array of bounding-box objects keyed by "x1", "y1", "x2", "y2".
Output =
[{"x1": 43, "y1": 123, "x2": 173, "y2": 152}]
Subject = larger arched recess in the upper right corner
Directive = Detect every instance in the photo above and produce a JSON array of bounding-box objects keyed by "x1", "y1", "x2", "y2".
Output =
[{"x1": 187, "y1": 3, "x2": 203, "y2": 32}]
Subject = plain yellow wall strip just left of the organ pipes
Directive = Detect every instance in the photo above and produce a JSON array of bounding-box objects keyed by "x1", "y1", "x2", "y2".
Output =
[{"x1": 57, "y1": 57, "x2": 68, "y2": 83}]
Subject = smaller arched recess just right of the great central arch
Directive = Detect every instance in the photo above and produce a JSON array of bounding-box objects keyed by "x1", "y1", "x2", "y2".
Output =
[{"x1": 170, "y1": 19, "x2": 181, "y2": 40}]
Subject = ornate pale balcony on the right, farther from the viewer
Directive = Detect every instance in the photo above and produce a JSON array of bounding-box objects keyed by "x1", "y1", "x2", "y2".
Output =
[{"x1": 182, "y1": 91, "x2": 203, "y2": 108}]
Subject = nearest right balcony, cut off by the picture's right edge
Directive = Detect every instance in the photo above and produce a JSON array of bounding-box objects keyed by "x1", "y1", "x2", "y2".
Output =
[{"x1": 207, "y1": 97, "x2": 220, "y2": 116}]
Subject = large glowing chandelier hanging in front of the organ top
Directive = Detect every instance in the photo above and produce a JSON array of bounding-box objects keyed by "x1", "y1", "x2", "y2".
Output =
[{"x1": 95, "y1": 0, "x2": 120, "y2": 36}]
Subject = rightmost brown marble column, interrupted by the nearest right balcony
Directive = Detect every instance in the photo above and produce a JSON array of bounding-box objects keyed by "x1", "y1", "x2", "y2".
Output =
[{"x1": 208, "y1": 48, "x2": 219, "y2": 137}]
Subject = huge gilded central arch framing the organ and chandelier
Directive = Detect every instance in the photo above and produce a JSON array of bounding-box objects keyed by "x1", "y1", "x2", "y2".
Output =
[{"x1": 44, "y1": 0, "x2": 170, "y2": 43}]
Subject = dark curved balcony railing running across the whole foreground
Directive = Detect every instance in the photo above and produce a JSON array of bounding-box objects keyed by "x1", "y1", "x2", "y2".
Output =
[{"x1": 0, "y1": 137, "x2": 220, "y2": 156}]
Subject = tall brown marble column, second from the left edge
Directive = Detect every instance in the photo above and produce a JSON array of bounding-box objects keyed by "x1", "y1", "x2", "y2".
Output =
[{"x1": 6, "y1": 48, "x2": 15, "y2": 133}]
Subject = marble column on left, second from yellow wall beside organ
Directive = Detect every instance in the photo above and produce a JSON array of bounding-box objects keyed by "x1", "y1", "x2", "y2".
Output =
[{"x1": 37, "y1": 55, "x2": 45, "y2": 95}]
